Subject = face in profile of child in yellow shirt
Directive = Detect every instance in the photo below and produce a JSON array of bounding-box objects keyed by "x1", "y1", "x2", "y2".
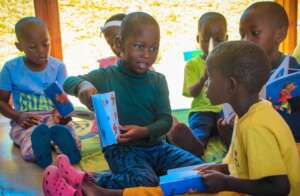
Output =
[{"x1": 207, "y1": 62, "x2": 228, "y2": 105}]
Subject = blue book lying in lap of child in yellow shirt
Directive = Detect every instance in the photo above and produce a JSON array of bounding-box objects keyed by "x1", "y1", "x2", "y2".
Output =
[{"x1": 160, "y1": 170, "x2": 206, "y2": 196}]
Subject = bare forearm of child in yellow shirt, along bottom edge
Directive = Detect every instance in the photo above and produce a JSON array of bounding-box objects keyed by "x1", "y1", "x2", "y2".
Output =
[{"x1": 201, "y1": 170, "x2": 290, "y2": 195}]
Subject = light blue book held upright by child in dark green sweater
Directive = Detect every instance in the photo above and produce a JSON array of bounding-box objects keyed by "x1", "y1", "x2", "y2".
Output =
[{"x1": 92, "y1": 92, "x2": 120, "y2": 148}]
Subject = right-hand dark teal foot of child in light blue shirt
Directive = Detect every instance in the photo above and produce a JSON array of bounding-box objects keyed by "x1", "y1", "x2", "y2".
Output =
[{"x1": 50, "y1": 125, "x2": 81, "y2": 164}]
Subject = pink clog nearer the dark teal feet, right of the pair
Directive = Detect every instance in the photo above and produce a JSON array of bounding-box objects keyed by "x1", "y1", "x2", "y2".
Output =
[{"x1": 56, "y1": 154, "x2": 89, "y2": 189}]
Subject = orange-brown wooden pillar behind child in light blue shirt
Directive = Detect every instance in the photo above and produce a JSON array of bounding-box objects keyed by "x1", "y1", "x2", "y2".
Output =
[{"x1": 34, "y1": 0, "x2": 63, "y2": 60}]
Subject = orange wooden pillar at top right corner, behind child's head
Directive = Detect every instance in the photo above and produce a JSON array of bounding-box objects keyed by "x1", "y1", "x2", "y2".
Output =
[{"x1": 276, "y1": 0, "x2": 298, "y2": 54}]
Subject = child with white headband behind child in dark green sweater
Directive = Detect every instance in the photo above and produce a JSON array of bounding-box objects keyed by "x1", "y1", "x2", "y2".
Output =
[{"x1": 98, "y1": 13, "x2": 126, "y2": 68}]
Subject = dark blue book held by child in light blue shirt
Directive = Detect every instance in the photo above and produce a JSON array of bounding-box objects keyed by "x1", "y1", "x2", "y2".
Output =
[{"x1": 44, "y1": 82, "x2": 74, "y2": 118}]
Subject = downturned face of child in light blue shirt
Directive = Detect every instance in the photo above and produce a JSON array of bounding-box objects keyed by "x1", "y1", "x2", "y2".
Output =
[{"x1": 16, "y1": 26, "x2": 50, "y2": 66}]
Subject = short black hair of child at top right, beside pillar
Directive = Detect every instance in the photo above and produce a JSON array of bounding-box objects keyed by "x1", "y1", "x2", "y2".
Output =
[{"x1": 242, "y1": 1, "x2": 289, "y2": 31}]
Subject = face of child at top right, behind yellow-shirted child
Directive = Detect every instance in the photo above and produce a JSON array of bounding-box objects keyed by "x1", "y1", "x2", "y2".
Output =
[{"x1": 240, "y1": 9, "x2": 280, "y2": 57}]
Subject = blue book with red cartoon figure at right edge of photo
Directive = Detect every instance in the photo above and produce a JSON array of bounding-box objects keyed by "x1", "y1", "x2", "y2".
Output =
[{"x1": 266, "y1": 72, "x2": 300, "y2": 114}]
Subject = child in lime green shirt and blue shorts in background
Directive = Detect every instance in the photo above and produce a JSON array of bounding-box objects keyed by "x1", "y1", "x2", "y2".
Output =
[{"x1": 168, "y1": 12, "x2": 227, "y2": 156}]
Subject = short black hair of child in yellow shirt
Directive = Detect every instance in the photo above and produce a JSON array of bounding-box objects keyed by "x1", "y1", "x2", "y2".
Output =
[{"x1": 207, "y1": 41, "x2": 271, "y2": 93}]
